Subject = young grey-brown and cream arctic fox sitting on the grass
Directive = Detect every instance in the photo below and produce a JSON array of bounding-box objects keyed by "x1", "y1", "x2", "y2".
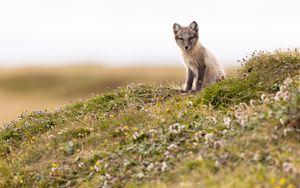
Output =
[{"x1": 173, "y1": 21, "x2": 225, "y2": 91}]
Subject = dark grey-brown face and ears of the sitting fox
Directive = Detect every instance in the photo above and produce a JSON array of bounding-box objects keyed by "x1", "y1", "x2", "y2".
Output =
[{"x1": 173, "y1": 21, "x2": 198, "y2": 51}]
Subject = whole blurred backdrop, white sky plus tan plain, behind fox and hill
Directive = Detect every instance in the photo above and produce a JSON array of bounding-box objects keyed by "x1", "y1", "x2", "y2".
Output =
[{"x1": 0, "y1": 0, "x2": 300, "y2": 123}]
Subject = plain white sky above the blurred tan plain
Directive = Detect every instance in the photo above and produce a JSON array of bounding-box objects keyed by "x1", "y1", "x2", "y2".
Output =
[{"x1": 0, "y1": 0, "x2": 300, "y2": 66}]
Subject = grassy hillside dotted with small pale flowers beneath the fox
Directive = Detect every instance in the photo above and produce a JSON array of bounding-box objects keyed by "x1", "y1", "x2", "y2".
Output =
[{"x1": 0, "y1": 50, "x2": 300, "y2": 188}]
